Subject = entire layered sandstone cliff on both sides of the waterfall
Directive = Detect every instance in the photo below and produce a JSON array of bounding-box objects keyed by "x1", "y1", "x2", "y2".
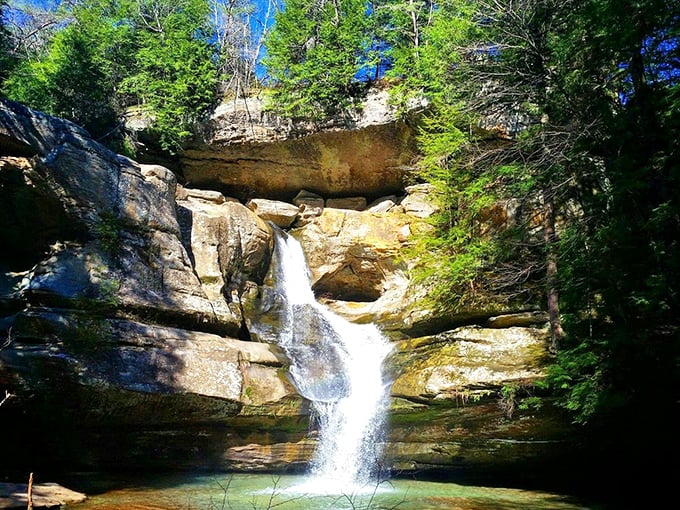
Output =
[{"x1": 0, "y1": 96, "x2": 566, "y2": 478}]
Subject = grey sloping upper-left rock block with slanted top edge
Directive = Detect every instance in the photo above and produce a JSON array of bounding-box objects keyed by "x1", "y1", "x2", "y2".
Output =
[{"x1": 0, "y1": 101, "x2": 234, "y2": 333}]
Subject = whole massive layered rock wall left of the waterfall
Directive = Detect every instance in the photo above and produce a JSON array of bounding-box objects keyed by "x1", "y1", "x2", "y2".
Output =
[{"x1": 0, "y1": 100, "x2": 308, "y2": 469}]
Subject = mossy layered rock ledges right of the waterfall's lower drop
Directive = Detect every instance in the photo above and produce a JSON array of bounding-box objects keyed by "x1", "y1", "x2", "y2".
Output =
[{"x1": 385, "y1": 326, "x2": 579, "y2": 474}]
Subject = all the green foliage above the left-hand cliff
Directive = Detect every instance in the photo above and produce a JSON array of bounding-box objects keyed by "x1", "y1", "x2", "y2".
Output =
[{"x1": 4, "y1": 0, "x2": 217, "y2": 152}]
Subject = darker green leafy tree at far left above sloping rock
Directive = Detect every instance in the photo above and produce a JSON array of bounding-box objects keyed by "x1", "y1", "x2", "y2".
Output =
[{"x1": 5, "y1": 0, "x2": 137, "y2": 139}]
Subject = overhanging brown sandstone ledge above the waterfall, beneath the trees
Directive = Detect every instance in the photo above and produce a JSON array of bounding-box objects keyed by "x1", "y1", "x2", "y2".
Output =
[{"x1": 180, "y1": 90, "x2": 415, "y2": 202}]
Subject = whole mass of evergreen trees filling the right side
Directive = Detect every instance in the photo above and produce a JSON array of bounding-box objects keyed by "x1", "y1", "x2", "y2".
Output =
[{"x1": 404, "y1": 0, "x2": 680, "y2": 430}]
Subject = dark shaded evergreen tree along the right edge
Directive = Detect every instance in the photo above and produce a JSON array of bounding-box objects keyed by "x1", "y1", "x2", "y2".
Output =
[{"x1": 553, "y1": 0, "x2": 680, "y2": 422}]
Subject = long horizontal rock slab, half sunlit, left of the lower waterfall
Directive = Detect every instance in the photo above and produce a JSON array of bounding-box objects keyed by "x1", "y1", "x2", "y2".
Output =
[{"x1": 3, "y1": 308, "x2": 292, "y2": 414}]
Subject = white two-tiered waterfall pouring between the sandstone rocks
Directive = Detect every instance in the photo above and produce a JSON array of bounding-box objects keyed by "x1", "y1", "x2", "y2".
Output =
[{"x1": 275, "y1": 229, "x2": 391, "y2": 492}]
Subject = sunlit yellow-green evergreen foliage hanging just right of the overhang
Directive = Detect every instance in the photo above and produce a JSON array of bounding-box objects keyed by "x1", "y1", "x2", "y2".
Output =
[{"x1": 392, "y1": 2, "x2": 540, "y2": 312}]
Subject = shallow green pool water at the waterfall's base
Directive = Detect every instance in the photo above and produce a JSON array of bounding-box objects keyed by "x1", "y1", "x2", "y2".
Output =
[{"x1": 66, "y1": 474, "x2": 589, "y2": 510}]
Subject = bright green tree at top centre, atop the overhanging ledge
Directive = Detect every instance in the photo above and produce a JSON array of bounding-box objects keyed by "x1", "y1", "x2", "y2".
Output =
[{"x1": 263, "y1": 0, "x2": 373, "y2": 119}]
